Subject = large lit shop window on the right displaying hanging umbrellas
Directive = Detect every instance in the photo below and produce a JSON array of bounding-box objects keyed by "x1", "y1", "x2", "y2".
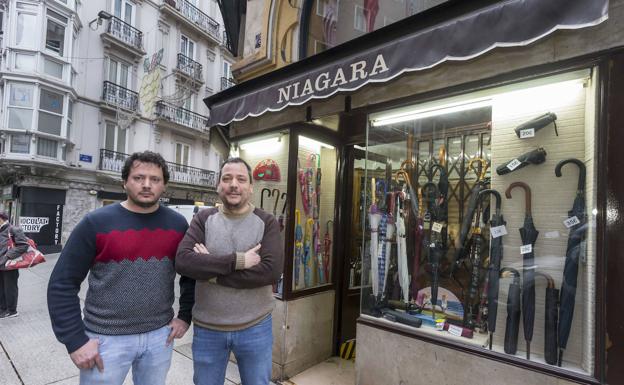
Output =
[{"x1": 364, "y1": 71, "x2": 597, "y2": 374}]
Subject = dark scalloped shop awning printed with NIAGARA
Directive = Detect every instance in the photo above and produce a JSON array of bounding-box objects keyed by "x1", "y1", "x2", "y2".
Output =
[{"x1": 204, "y1": 0, "x2": 609, "y2": 126}]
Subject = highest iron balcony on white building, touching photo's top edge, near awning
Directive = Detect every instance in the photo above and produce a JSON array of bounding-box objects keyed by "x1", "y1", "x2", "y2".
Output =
[{"x1": 160, "y1": 0, "x2": 221, "y2": 45}]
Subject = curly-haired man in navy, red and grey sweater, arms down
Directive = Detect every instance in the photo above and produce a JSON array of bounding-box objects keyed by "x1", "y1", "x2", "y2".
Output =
[{"x1": 48, "y1": 151, "x2": 195, "y2": 385}]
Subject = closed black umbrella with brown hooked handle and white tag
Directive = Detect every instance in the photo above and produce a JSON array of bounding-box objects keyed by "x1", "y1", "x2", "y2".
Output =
[{"x1": 505, "y1": 182, "x2": 539, "y2": 360}]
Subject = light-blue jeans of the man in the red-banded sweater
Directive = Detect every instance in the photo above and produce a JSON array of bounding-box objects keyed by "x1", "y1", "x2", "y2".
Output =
[{"x1": 80, "y1": 326, "x2": 173, "y2": 385}]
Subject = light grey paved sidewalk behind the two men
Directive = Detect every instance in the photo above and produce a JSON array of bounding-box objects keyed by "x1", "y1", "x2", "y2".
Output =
[{"x1": 0, "y1": 254, "x2": 241, "y2": 385}]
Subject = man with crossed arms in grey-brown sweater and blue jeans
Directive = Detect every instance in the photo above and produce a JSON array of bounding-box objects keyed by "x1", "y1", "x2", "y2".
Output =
[{"x1": 176, "y1": 158, "x2": 284, "y2": 385}]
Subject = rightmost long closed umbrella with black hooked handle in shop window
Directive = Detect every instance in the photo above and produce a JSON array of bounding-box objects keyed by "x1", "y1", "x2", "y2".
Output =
[{"x1": 555, "y1": 158, "x2": 587, "y2": 366}]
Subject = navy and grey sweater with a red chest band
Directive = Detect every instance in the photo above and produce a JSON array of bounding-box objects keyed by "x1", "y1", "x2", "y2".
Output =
[{"x1": 48, "y1": 203, "x2": 195, "y2": 353}]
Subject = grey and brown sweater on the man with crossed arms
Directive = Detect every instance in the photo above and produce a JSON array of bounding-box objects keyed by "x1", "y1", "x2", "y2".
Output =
[{"x1": 176, "y1": 205, "x2": 284, "y2": 330}]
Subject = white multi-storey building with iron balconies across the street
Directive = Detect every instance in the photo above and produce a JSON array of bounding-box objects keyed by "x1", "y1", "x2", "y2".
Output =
[{"x1": 0, "y1": 0, "x2": 233, "y2": 249}]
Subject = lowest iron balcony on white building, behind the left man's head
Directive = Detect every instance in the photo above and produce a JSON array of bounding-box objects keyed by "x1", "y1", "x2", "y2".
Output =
[{"x1": 99, "y1": 149, "x2": 217, "y2": 189}]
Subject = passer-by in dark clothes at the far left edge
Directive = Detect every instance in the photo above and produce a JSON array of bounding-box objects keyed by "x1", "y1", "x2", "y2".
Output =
[{"x1": 0, "y1": 211, "x2": 28, "y2": 319}]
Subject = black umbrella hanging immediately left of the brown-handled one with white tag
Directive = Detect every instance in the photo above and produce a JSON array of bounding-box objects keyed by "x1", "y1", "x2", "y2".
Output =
[{"x1": 479, "y1": 189, "x2": 506, "y2": 350}]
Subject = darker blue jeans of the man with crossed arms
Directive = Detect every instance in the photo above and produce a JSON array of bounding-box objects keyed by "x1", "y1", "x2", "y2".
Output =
[{"x1": 193, "y1": 315, "x2": 273, "y2": 385}]
